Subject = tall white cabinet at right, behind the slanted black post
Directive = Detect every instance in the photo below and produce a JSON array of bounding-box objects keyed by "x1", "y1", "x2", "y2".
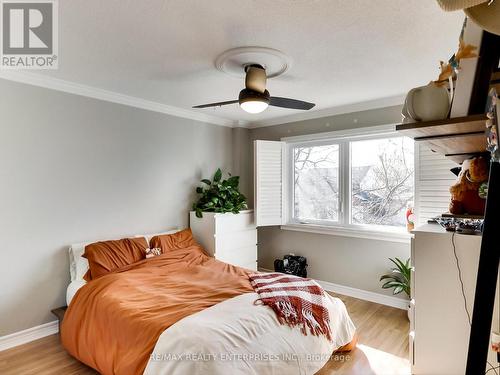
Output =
[{"x1": 409, "y1": 224, "x2": 499, "y2": 375}]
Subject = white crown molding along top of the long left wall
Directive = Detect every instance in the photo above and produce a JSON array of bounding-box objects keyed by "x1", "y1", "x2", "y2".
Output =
[{"x1": 0, "y1": 70, "x2": 238, "y2": 127}]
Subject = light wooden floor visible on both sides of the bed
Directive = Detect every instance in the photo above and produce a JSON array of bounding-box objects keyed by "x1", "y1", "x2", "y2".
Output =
[{"x1": 0, "y1": 295, "x2": 410, "y2": 375}]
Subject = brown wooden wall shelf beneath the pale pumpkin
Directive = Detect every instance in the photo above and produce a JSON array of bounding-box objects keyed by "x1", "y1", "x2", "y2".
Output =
[{"x1": 396, "y1": 114, "x2": 487, "y2": 164}]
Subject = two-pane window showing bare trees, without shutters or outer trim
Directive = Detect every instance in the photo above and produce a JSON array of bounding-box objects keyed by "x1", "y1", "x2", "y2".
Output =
[{"x1": 285, "y1": 133, "x2": 414, "y2": 230}]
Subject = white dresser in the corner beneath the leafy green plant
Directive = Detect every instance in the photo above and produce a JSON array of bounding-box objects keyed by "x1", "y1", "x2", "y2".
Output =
[{"x1": 189, "y1": 210, "x2": 257, "y2": 271}]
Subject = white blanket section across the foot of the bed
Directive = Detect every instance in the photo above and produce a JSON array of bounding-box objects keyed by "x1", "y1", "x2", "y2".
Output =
[{"x1": 144, "y1": 293, "x2": 355, "y2": 375}]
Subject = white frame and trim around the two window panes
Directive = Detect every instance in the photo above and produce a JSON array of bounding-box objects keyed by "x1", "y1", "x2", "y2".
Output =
[{"x1": 281, "y1": 124, "x2": 417, "y2": 243}]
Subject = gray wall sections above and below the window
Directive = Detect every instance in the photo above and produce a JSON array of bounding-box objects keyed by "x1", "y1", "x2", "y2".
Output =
[{"x1": 248, "y1": 106, "x2": 410, "y2": 297}]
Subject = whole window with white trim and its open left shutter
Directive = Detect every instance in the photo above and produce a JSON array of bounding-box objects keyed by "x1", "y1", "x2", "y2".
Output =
[{"x1": 254, "y1": 126, "x2": 418, "y2": 243}]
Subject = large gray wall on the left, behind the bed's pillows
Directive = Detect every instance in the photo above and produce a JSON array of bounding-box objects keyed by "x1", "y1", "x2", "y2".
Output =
[{"x1": 0, "y1": 80, "x2": 234, "y2": 336}]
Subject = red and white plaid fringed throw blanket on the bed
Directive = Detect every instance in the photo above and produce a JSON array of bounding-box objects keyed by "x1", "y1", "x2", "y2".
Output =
[{"x1": 249, "y1": 273, "x2": 332, "y2": 341}]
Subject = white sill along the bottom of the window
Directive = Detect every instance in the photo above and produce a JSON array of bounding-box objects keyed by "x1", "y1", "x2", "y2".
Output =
[{"x1": 281, "y1": 223, "x2": 412, "y2": 244}]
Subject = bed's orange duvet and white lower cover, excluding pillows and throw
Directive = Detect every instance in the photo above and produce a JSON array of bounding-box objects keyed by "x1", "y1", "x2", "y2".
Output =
[{"x1": 61, "y1": 231, "x2": 355, "y2": 375}]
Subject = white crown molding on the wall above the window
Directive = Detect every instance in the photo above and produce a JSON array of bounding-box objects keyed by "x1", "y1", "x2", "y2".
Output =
[{"x1": 246, "y1": 94, "x2": 406, "y2": 129}]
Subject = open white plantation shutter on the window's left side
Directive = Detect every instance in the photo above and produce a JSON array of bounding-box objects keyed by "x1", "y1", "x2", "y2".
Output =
[{"x1": 254, "y1": 141, "x2": 285, "y2": 227}]
